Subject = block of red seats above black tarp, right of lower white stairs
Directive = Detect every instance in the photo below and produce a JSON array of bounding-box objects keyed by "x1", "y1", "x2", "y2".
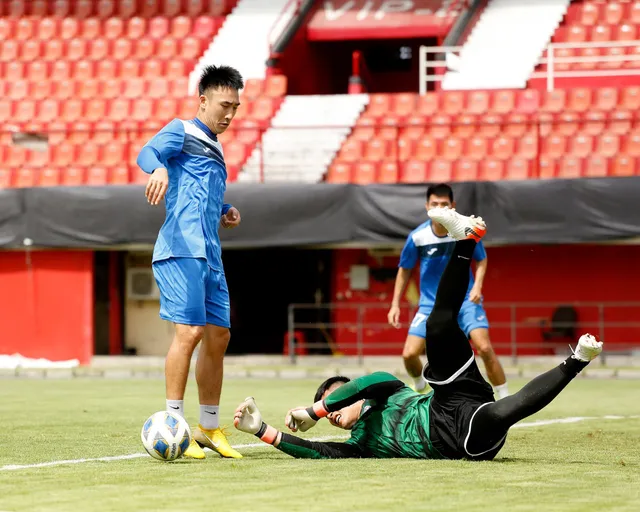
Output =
[{"x1": 327, "y1": 87, "x2": 640, "y2": 184}]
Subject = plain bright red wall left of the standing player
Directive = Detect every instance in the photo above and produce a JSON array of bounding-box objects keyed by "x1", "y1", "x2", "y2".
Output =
[{"x1": 0, "y1": 251, "x2": 93, "y2": 364}]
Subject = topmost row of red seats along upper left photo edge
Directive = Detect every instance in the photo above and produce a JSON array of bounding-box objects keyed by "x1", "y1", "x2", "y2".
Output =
[{"x1": 0, "y1": 0, "x2": 236, "y2": 19}]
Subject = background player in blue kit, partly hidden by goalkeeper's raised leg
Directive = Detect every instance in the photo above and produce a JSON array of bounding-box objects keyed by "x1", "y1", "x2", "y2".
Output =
[{"x1": 388, "y1": 183, "x2": 508, "y2": 398}]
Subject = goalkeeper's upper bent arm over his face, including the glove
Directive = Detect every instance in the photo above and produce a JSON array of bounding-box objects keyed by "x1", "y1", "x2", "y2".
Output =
[{"x1": 285, "y1": 372, "x2": 404, "y2": 432}]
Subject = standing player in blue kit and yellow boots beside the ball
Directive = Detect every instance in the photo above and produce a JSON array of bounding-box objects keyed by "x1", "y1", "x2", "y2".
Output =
[{"x1": 138, "y1": 66, "x2": 244, "y2": 459}]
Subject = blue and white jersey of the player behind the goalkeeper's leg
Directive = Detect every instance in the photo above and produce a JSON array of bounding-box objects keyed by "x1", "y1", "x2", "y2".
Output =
[{"x1": 398, "y1": 220, "x2": 487, "y2": 308}]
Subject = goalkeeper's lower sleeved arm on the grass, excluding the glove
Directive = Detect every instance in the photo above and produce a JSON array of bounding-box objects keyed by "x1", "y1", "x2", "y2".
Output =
[{"x1": 256, "y1": 422, "x2": 363, "y2": 459}]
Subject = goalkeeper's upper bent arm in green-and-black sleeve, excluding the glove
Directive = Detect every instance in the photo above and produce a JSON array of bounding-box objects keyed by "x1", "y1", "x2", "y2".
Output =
[{"x1": 300, "y1": 372, "x2": 404, "y2": 421}]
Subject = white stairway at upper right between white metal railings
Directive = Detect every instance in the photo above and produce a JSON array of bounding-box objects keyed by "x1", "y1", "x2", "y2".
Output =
[{"x1": 442, "y1": 0, "x2": 570, "y2": 90}]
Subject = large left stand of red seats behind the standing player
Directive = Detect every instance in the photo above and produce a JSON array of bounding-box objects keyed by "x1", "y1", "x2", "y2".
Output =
[{"x1": 0, "y1": 0, "x2": 286, "y2": 187}]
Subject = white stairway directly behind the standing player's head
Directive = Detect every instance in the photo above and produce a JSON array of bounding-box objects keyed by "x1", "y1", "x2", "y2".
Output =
[{"x1": 189, "y1": 0, "x2": 289, "y2": 92}]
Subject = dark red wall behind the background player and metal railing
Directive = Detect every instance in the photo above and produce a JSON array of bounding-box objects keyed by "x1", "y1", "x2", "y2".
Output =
[{"x1": 331, "y1": 245, "x2": 640, "y2": 354}]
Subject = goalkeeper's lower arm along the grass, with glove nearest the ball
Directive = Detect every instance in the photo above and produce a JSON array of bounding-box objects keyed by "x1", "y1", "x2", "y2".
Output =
[{"x1": 233, "y1": 397, "x2": 363, "y2": 459}]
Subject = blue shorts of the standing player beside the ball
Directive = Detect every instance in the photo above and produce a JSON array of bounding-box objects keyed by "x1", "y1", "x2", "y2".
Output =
[{"x1": 153, "y1": 258, "x2": 231, "y2": 328}]
